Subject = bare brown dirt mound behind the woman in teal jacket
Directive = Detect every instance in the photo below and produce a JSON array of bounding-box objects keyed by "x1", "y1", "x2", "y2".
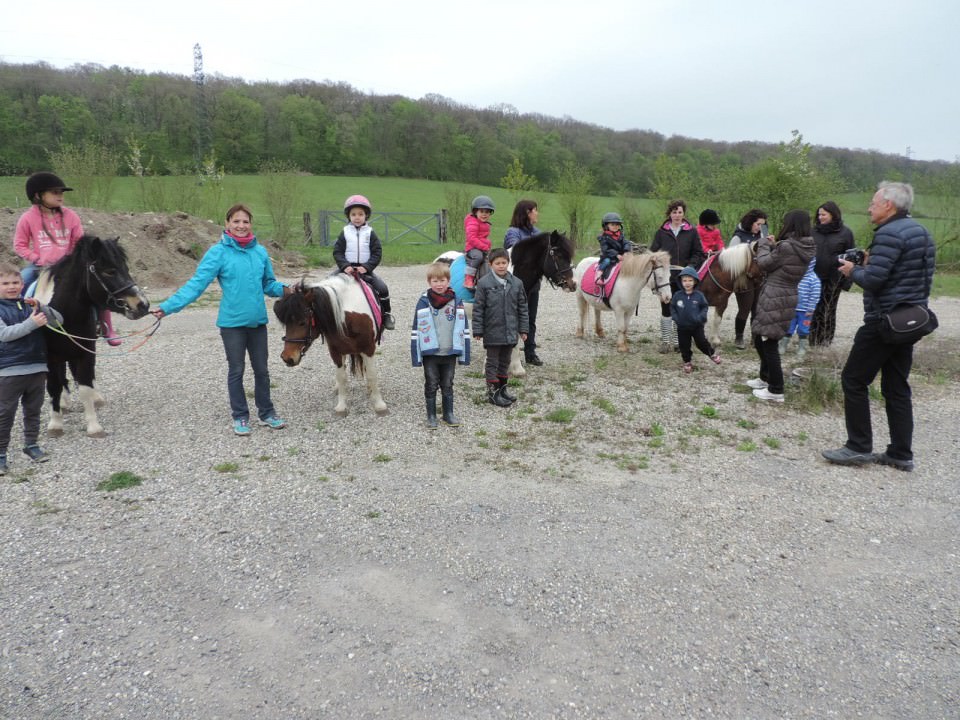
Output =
[{"x1": 0, "y1": 208, "x2": 299, "y2": 288}]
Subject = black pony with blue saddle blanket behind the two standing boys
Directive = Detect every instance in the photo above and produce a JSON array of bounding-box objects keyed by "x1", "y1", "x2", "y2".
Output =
[{"x1": 437, "y1": 230, "x2": 577, "y2": 377}]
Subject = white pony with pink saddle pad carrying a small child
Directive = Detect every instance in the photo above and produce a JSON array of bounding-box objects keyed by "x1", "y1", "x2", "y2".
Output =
[{"x1": 573, "y1": 251, "x2": 671, "y2": 352}]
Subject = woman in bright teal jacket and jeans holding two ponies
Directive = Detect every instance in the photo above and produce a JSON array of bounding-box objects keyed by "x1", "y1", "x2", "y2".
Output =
[{"x1": 151, "y1": 205, "x2": 286, "y2": 436}]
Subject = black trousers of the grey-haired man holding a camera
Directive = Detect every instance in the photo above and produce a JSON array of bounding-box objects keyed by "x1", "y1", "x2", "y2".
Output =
[{"x1": 840, "y1": 321, "x2": 913, "y2": 460}]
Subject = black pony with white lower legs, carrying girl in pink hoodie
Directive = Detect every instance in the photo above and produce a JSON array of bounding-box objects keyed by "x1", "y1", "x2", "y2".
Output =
[{"x1": 34, "y1": 235, "x2": 150, "y2": 438}]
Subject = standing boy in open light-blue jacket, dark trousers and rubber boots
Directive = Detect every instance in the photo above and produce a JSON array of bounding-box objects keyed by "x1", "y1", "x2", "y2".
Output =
[{"x1": 410, "y1": 262, "x2": 470, "y2": 430}]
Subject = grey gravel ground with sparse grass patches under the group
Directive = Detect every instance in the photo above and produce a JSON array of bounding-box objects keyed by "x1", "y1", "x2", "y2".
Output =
[{"x1": 0, "y1": 267, "x2": 960, "y2": 720}]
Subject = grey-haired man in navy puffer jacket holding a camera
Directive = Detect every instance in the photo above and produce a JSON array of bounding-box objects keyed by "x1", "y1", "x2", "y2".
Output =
[{"x1": 823, "y1": 182, "x2": 936, "y2": 472}]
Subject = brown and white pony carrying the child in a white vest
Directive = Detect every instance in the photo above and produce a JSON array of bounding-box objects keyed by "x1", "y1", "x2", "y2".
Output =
[{"x1": 273, "y1": 275, "x2": 389, "y2": 417}]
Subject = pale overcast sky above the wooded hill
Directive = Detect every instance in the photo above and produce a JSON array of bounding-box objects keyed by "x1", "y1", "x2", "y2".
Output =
[{"x1": 0, "y1": 0, "x2": 960, "y2": 162}]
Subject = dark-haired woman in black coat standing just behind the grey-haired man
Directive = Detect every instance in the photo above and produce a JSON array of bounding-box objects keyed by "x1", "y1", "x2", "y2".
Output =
[{"x1": 810, "y1": 200, "x2": 855, "y2": 346}]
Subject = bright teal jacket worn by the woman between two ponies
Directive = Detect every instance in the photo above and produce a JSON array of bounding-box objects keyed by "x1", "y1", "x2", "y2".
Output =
[{"x1": 160, "y1": 233, "x2": 284, "y2": 327}]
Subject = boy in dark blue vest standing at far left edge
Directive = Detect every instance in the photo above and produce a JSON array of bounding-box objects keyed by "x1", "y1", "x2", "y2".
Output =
[{"x1": 0, "y1": 263, "x2": 63, "y2": 475}]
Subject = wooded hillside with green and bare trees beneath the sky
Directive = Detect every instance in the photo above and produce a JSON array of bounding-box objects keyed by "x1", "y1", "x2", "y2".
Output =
[{"x1": 0, "y1": 63, "x2": 958, "y2": 200}]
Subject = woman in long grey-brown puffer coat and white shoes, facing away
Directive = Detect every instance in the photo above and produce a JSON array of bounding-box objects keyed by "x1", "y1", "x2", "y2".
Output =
[{"x1": 747, "y1": 210, "x2": 816, "y2": 402}]
